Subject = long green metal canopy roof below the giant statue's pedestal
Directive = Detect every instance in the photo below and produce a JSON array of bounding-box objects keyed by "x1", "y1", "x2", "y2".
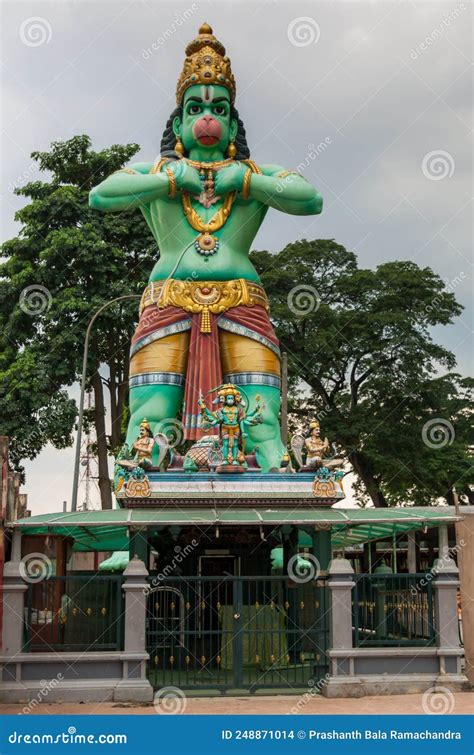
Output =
[{"x1": 9, "y1": 506, "x2": 462, "y2": 551}]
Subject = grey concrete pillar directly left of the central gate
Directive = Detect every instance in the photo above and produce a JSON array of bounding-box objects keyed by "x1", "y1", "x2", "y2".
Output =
[{"x1": 123, "y1": 556, "x2": 148, "y2": 653}]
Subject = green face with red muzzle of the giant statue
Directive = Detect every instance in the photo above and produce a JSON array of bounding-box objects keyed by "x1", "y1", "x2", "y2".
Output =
[{"x1": 173, "y1": 84, "x2": 237, "y2": 157}]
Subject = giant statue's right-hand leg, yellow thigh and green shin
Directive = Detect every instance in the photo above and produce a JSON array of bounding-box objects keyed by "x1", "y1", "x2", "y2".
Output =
[{"x1": 219, "y1": 329, "x2": 286, "y2": 472}]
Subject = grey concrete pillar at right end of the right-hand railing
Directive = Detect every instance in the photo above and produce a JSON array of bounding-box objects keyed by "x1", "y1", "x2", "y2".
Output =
[{"x1": 433, "y1": 557, "x2": 460, "y2": 648}]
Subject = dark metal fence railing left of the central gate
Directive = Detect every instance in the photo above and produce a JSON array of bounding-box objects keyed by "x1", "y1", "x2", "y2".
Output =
[{"x1": 24, "y1": 574, "x2": 124, "y2": 652}]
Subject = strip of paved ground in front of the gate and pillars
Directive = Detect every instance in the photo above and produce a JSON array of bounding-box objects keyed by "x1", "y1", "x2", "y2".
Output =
[{"x1": 0, "y1": 692, "x2": 474, "y2": 716}]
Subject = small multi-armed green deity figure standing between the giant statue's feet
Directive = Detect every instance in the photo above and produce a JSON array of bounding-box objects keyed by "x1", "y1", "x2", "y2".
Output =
[{"x1": 199, "y1": 383, "x2": 264, "y2": 472}]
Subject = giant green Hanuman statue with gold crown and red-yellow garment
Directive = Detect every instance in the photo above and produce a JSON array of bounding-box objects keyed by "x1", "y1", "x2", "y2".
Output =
[{"x1": 90, "y1": 24, "x2": 322, "y2": 472}]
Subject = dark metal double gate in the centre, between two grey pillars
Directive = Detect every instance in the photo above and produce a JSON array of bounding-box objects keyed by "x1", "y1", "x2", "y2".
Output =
[{"x1": 146, "y1": 576, "x2": 328, "y2": 692}]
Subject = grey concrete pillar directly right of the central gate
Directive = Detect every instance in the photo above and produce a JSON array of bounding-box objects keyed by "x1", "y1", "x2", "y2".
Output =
[{"x1": 329, "y1": 558, "x2": 355, "y2": 650}]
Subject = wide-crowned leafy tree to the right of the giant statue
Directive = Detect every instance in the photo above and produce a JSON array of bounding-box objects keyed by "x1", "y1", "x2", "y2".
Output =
[{"x1": 252, "y1": 240, "x2": 472, "y2": 506}]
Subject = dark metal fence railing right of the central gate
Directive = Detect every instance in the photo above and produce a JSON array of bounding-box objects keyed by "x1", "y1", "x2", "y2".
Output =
[{"x1": 352, "y1": 574, "x2": 436, "y2": 647}]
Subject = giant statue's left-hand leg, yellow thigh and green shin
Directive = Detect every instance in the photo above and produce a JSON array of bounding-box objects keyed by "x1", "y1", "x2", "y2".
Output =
[{"x1": 126, "y1": 331, "x2": 189, "y2": 463}]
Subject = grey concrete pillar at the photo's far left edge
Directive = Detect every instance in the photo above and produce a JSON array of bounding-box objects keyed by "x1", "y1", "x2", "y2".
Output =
[{"x1": 2, "y1": 531, "x2": 28, "y2": 657}]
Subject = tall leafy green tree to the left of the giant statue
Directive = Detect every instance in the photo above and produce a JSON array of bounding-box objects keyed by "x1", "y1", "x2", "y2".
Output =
[{"x1": 0, "y1": 135, "x2": 156, "y2": 508}]
